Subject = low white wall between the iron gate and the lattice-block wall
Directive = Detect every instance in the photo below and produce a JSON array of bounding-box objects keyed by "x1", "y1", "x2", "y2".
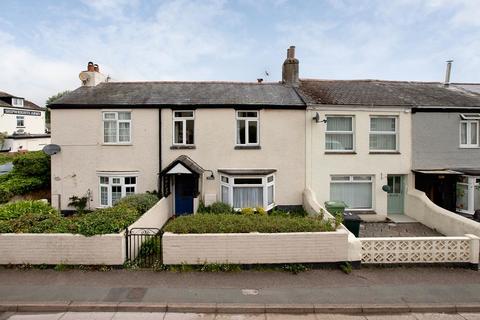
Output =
[{"x1": 162, "y1": 229, "x2": 348, "y2": 264}]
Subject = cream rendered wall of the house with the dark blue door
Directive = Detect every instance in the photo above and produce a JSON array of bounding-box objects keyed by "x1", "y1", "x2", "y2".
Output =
[{"x1": 162, "y1": 108, "x2": 305, "y2": 205}]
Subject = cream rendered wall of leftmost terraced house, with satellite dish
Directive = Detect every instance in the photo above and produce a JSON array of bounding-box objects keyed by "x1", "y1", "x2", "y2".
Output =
[{"x1": 51, "y1": 109, "x2": 159, "y2": 209}]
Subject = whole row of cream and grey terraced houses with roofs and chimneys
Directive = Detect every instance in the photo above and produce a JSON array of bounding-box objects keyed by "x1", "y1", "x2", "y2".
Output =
[{"x1": 50, "y1": 47, "x2": 480, "y2": 229}]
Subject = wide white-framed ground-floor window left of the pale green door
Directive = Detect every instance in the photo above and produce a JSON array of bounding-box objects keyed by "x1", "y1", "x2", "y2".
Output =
[{"x1": 330, "y1": 176, "x2": 373, "y2": 210}]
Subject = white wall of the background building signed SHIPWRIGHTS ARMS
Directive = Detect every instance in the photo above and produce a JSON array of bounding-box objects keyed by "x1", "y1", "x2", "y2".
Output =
[{"x1": 0, "y1": 107, "x2": 45, "y2": 134}]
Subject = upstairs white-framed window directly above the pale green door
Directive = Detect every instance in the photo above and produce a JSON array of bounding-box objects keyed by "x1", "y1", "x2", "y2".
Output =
[{"x1": 370, "y1": 117, "x2": 398, "y2": 152}]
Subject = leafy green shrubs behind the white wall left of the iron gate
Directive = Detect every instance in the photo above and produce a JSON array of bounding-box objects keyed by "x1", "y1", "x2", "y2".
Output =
[{"x1": 0, "y1": 194, "x2": 158, "y2": 236}]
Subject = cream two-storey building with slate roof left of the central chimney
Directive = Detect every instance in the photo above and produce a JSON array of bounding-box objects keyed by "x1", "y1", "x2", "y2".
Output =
[{"x1": 50, "y1": 58, "x2": 305, "y2": 215}]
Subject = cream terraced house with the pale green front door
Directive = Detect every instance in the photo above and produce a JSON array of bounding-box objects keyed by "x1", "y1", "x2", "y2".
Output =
[{"x1": 299, "y1": 79, "x2": 412, "y2": 220}]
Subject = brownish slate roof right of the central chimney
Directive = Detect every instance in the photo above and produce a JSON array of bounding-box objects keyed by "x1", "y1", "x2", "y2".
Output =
[{"x1": 300, "y1": 79, "x2": 480, "y2": 109}]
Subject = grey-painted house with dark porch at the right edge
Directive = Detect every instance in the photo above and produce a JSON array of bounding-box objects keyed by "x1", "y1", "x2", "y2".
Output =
[{"x1": 412, "y1": 80, "x2": 480, "y2": 215}]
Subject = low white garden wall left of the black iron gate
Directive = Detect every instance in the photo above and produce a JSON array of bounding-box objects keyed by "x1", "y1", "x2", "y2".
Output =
[{"x1": 0, "y1": 233, "x2": 125, "y2": 265}]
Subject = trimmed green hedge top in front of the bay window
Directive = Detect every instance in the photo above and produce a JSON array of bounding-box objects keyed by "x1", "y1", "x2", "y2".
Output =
[{"x1": 164, "y1": 214, "x2": 335, "y2": 234}]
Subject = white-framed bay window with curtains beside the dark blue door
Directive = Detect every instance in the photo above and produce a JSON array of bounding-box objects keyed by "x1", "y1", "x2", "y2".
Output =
[{"x1": 220, "y1": 175, "x2": 275, "y2": 210}]
